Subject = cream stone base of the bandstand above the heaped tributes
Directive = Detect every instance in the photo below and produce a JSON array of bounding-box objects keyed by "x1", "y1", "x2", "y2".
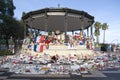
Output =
[{"x1": 25, "y1": 45, "x2": 94, "y2": 56}]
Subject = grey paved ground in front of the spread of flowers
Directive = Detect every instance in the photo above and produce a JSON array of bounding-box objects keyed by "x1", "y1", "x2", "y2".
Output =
[{"x1": 0, "y1": 69, "x2": 120, "y2": 80}]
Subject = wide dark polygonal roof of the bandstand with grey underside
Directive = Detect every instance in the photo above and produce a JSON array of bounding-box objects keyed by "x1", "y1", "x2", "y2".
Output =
[{"x1": 22, "y1": 8, "x2": 94, "y2": 31}]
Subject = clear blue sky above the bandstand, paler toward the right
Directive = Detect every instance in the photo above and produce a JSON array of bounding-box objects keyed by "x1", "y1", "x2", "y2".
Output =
[{"x1": 13, "y1": 0, "x2": 120, "y2": 44}]
